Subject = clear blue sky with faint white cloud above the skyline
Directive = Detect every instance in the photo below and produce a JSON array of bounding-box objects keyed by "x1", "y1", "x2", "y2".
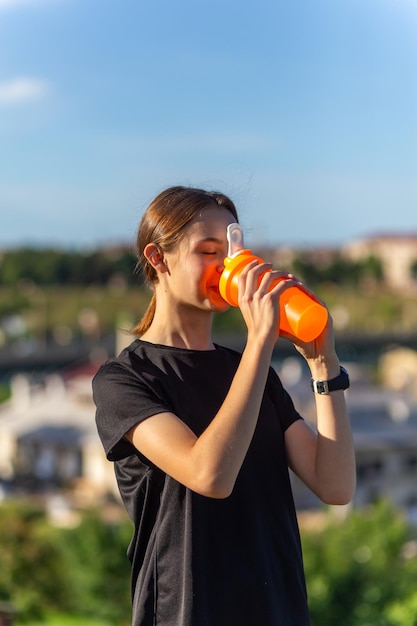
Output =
[{"x1": 0, "y1": 0, "x2": 417, "y2": 247}]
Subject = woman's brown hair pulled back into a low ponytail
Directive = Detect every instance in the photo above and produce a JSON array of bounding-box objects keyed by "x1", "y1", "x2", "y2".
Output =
[{"x1": 132, "y1": 186, "x2": 238, "y2": 335}]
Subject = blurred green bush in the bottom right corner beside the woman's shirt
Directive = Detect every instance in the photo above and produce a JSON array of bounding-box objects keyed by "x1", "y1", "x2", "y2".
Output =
[{"x1": 303, "y1": 502, "x2": 417, "y2": 626}]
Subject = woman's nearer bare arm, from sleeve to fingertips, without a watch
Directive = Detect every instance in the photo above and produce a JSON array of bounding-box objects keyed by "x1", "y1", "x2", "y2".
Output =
[{"x1": 127, "y1": 264, "x2": 294, "y2": 498}]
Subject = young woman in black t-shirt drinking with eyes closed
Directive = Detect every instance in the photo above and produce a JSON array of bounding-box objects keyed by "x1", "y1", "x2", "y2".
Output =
[{"x1": 93, "y1": 187, "x2": 355, "y2": 626}]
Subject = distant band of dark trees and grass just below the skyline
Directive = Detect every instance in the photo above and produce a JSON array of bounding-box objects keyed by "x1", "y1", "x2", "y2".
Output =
[{"x1": 0, "y1": 248, "x2": 417, "y2": 344}]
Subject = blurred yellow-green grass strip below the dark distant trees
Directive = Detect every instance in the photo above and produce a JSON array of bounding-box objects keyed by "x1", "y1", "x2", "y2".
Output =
[{"x1": 4, "y1": 284, "x2": 417, "y2": 341}]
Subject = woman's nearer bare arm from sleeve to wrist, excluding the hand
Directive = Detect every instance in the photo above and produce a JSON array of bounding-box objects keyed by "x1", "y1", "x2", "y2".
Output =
[{"x1": 127, "y1": 334, "x2": 270, "y2": 498}]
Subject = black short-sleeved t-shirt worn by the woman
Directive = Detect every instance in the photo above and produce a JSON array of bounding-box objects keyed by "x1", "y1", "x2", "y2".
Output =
[{"x1": 93, "y1": 340, "x2": 310, "y2": 626}]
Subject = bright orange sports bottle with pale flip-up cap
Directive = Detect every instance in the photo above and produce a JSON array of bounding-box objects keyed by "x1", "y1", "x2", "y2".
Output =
[{"x1": 219, "y1": 224, "x2": 328, "y2": 342}]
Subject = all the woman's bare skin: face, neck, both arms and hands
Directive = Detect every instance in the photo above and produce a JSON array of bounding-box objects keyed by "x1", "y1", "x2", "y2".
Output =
[{"x1": 126, "y1": 208, "x2": 355, "y2": 504}]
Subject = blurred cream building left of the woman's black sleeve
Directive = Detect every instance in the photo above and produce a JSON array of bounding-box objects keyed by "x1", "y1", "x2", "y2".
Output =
[{"x1": 0, "y1": 365, "x2": 118, "y2": 503}]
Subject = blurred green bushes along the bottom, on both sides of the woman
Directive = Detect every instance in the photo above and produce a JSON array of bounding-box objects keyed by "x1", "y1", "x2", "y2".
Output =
[{"x1": 0, "y1": 494, "x2": 417, "y2": 626}]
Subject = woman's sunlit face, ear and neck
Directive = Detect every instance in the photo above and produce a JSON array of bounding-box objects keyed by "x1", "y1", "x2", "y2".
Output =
[{"x1": 142, "y1": 208, "x2": 235, "y2": 349}]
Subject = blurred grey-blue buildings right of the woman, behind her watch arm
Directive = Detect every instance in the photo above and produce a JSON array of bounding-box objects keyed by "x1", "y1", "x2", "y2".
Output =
[{"x1": 277, "y1": 350, "x2": 417, "y2": 525}]
